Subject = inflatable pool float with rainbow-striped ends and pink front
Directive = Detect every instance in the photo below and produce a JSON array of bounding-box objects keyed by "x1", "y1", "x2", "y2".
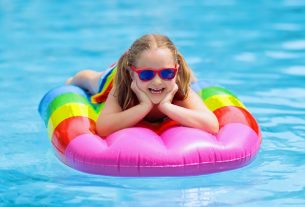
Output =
[{"x1": 39, "y1": 82, "x2": 261, "y2": 176}]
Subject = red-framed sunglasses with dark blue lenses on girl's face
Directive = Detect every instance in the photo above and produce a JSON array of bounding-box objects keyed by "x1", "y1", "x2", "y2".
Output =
[{"x1": 131, "y1": 65, "x2": 178, "y2": 81}]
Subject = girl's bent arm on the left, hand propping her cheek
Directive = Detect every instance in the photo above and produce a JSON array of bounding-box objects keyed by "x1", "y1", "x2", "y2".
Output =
[{"x1": 96, "y1": 82, "x2": 153, "y2": 137}]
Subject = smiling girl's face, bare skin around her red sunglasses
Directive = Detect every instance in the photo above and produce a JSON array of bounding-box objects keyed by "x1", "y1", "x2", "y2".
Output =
[{"x1": 132, "y1": 48, "x2": 179, "y2": 104}]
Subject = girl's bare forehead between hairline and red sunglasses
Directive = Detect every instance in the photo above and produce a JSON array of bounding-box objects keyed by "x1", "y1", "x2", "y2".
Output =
[{"x1": 136, "y1": 48, "x2": 175, "y2": 68}]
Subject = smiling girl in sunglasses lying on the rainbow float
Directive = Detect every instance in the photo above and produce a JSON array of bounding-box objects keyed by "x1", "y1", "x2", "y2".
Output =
[{"x1": 67, "y1": 34, "x2": 219, "y2": 136}]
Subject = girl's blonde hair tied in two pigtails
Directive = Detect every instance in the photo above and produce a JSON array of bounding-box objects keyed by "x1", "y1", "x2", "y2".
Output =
[{"x1": 114, "y1": 34, "x2": 195, "y2": 110}]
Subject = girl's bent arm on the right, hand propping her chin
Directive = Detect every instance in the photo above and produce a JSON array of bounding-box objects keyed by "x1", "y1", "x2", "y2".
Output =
[{"x1": 159, "y1": 86, "x2": 219, "y2": 134}]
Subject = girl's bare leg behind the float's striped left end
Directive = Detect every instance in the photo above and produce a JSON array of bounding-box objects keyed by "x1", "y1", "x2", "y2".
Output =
[{"x1": 66, "y1": 70, "x2": 102, "y2": 94}]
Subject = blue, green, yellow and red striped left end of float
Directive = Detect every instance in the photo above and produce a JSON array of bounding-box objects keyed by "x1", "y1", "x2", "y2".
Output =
[{"x1": 39, "y1": 86, "x2": 103, "y2": 158}]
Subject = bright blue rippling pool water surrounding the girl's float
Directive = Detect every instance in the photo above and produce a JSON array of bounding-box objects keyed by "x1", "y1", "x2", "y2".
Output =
[{"x1": 0, "y1": 0, "x2": 305, "y2": 207}]
